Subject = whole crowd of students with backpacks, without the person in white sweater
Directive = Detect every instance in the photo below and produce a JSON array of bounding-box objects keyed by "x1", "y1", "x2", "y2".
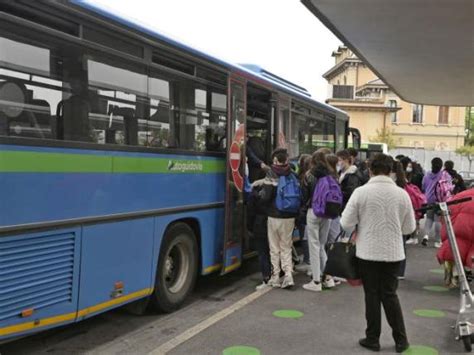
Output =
[{"x1": 247, "y1": 148, "x2": 465, "y2": 292}]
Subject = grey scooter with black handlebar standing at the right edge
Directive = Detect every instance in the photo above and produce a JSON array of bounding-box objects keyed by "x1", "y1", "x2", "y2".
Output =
[{"x1": 420, "y1": 197, "x2": 474, "y2": 352}]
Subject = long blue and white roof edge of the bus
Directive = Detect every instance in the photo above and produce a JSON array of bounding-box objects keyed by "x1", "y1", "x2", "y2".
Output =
[{"x1": 72, "y1": 0, "x2": 347, "y2": 116}]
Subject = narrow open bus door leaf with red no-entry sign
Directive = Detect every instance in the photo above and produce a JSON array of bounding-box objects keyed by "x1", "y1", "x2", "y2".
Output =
[{"x1": 221, "y1": 77, "x2": 247, "y2": 274}]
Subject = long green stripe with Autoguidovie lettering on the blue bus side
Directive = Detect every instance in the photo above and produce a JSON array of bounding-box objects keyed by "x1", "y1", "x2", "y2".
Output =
[{"x1": 0, "y1": 151, "x2": 225, "y2": 174}]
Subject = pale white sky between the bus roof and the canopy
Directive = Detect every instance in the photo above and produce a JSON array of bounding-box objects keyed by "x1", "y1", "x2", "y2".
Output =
[{"x1": 90, "y1": 0, "x2": 341, "y2": 101}]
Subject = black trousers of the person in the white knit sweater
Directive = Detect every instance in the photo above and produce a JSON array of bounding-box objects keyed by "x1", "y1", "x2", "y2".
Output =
[{"x1": 358, "y1": 259, "x2": 408, "y2": 344}]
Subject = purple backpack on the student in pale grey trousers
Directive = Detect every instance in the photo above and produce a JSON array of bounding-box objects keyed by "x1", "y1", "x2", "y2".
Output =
[{"x1": 311, "y1": 175, "x2": 342, "y2": 219}]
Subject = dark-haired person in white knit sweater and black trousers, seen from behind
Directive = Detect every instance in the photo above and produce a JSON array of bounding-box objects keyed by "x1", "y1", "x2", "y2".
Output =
[{"x1": 341, "y1": 154, "x2": 416, "y2": 353}]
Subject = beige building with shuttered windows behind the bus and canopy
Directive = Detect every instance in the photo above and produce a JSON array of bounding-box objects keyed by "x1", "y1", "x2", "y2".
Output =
[{"x1": 323, "y1": 46, "x2": 466, "y2": 150}]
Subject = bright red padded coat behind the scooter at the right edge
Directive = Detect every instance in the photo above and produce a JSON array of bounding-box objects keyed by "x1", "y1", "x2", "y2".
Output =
[{"x1": 437, "y1": 189, "x2": 474, "y2": 268}]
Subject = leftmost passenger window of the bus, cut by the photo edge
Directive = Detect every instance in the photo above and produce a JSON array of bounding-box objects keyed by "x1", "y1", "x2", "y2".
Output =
[{"x1": 0, "y1": 34, "x2": 62, "y2": 139}]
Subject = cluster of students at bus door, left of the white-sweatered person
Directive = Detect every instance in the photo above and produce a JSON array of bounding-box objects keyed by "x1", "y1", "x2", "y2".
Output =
[{"x1": 247, "y1": 148, "x2": 369, "y2": 291}]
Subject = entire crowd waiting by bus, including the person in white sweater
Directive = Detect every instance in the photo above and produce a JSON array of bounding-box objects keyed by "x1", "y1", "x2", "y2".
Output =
[{"x1": 248, "y1": 148, "x2": 464, "y2": 353}]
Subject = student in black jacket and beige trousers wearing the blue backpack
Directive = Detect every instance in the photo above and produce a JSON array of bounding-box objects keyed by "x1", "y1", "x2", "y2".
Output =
[{"x1": 252, "y1": 148, "x2": 297, "y2": 288}]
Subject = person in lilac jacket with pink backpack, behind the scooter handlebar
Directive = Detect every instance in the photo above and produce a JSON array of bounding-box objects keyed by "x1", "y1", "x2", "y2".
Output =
[{"x1": 421, "y1": 158, "x2": 451, "y2": 248}]
